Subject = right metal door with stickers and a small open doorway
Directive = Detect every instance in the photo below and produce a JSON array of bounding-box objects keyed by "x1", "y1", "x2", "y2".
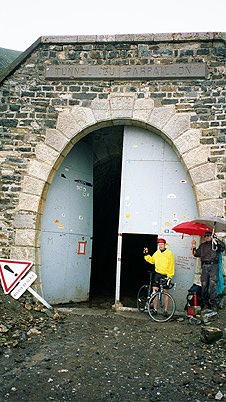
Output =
[{"x1": 116, "y1": 126, "x2": 197, "y2": 309}]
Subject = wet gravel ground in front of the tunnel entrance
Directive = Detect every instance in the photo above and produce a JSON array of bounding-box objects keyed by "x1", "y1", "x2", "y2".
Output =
[{"x1": 0, "y1": 296, "x2": 226, "y2": 402}]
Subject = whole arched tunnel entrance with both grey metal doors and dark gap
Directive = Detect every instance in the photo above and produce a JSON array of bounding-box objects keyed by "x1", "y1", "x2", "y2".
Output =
[{"x1": 41, "y1": 126, "x2": 196, "y2": 307}]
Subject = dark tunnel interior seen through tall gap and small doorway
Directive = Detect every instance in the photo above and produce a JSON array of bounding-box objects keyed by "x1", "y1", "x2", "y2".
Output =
[{"x1": 87, "y1": 126, "x2": 156, "y2": 306}]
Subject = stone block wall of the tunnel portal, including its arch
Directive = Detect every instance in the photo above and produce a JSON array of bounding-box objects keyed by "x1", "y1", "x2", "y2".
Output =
[{"x1": 0, "y1": 33, "x2": 226, "y2": 288}]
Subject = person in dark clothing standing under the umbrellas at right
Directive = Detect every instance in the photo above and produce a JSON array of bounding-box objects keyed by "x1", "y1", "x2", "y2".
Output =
[{"x1": 192, "y1": 232, "x2": 226, "y2": 311}]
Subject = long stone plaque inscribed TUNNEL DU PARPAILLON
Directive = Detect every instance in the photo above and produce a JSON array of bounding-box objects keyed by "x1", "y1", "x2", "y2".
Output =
[{"x1": 45, "y1": 63, "x2": 207, "y2": 80}]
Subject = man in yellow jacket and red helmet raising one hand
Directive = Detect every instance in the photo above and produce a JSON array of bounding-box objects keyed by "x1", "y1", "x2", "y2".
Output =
[{"x1": 144, "y1": 238, "x2": 174, "y2": 317}]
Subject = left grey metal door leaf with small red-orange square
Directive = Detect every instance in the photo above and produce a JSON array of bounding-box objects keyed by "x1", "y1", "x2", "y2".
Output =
[{"x1": 41, "y1": 141, "x2": 93, "y2": 304}]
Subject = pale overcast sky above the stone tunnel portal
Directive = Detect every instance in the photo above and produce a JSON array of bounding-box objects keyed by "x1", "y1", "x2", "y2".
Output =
[{"x1": 0, "y1": 0, "x2": 226, "y2": 51}]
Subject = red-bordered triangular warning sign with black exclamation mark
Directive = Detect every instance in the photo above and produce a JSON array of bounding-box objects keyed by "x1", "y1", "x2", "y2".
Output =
[{"x1": 0, "y1": 259, "x2": 33, "y2": 294}]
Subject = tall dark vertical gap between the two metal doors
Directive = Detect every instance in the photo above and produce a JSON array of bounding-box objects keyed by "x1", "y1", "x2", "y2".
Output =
[{"x1": 90, "y1": 126, "x2": 123, "y2": 298}]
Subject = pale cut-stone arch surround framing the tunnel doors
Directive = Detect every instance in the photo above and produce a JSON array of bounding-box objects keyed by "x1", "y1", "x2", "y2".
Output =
[{"x1": 12, "y1": 93, "x2": 223, "y2": 296}]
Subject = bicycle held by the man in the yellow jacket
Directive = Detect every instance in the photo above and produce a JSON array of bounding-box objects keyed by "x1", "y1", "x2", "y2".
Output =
[{"x1": 137, "y1": 271, "x2": 176, "y2": 322}]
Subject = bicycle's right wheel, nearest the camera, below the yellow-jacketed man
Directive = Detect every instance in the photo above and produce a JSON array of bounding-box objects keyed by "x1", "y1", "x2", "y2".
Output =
[{"x1": 148, "y1": 292, "x2": 176, "y2": 322}]
